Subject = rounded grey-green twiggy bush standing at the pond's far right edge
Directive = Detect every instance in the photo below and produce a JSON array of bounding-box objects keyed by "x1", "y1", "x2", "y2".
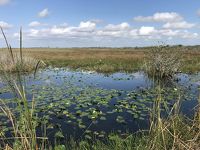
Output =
[{"x1": 144, "y1": 45, "x2": 183, "y2": 79}]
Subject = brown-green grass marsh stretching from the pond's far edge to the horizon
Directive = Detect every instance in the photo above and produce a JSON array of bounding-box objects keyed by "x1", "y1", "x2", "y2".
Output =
[{"x1": 0, "y1": 47, "x2": 200, "y2": 73}]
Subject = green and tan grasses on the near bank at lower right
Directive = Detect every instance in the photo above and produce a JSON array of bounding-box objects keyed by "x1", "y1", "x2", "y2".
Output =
[{"x1": 58, "y1": 87, "x2": 200, "y2": 150}]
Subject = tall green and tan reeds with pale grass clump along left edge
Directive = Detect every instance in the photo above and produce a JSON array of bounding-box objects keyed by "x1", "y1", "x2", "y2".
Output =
[{"x1": 0, "y1": 28, "x2": 46, "y2": 150}]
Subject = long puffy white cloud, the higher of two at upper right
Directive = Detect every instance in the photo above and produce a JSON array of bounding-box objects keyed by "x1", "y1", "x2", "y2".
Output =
[{"x1": 134, "y1": 12, "x2": 183, "y2": 22}]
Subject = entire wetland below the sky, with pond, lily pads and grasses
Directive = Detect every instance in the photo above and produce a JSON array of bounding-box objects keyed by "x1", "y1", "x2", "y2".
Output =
[{"x1": 0, "y1": 29, "x2": 200, "y2": 150}]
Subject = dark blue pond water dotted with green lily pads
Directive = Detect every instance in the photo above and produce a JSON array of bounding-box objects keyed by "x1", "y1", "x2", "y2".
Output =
[{"x1": 0, "y1": 68, "x2": 200, "y2": 140}]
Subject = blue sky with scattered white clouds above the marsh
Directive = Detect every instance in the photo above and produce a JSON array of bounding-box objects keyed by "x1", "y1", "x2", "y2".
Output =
[{"x1": 0, "y1": 0, "x2": 200, "y2": 47}]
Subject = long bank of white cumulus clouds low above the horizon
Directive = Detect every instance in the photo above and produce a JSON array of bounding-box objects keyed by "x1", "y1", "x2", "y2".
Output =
[{"x1": 18, "y1": 21, "x2": 199, "y2": 41}]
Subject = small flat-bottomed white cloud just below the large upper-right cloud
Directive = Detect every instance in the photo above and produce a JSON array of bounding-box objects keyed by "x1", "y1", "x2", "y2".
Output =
[{"x1": 163, "y1": 21, "x2": 195, "y2": 29}]
